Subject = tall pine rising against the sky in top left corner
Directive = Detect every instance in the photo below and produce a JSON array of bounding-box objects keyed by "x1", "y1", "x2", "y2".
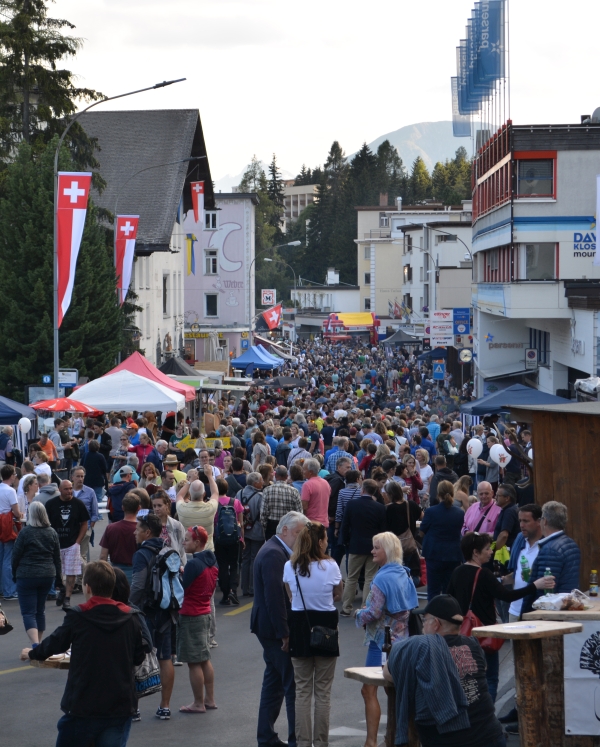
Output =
[{"x1": 0, "y1": 0, "x2": 102, "y2": 175}]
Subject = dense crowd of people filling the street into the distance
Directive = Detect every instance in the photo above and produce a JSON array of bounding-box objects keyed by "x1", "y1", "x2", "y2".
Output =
[{"x1": 0, "y1": 340, "x2": 580, "y2": 747}]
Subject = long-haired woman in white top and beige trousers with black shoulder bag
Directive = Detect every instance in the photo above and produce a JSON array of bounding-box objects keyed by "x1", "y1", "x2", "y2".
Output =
[{"x1": 283, "y1": 521, "x2": 343, "y2": 747}]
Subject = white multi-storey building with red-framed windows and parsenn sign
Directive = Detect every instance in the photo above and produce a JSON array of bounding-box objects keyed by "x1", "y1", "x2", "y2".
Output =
[{"x1": 472, "y1": 122, "x2": 600, "y2": 396}]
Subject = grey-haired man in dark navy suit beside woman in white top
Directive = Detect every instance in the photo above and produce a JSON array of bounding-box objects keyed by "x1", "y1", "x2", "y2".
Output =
[{"x1": 250, "y1": 511, "x2": 308, "y2": 747}]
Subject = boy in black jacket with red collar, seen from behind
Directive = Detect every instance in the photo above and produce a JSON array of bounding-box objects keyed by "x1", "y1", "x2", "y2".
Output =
[{"x1": 21, "y1": 560, "x2": 145, "y2": 747}]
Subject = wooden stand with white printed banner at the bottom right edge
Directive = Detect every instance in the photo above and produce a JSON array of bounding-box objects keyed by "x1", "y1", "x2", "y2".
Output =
[{"x1": 523, "y1": 601, "x2": 600, "y2": 747}]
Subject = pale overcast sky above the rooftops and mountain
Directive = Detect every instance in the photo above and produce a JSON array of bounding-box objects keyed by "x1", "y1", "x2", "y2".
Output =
[{"x1": 51, "y1": 0, "x2": 600, "y2": 179}]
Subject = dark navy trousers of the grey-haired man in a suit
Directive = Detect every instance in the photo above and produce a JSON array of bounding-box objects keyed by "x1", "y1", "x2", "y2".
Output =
[{"x1": 256, "y1": 636, "x2": 296, "y2": 747}]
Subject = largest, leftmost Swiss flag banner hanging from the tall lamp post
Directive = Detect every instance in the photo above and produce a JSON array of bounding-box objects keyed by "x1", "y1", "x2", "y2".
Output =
[{"x1": 56, "y1": 177, "x2": 92, "y2": 327}]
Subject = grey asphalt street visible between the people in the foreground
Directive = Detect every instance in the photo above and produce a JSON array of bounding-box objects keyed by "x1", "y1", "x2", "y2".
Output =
[{"x1": 0, "y1": 524, "x2": 518, "y2": 747}]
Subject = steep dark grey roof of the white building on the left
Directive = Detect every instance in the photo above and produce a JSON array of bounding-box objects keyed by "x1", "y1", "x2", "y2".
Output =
[{"x1": 79, "y1": 109, "x2": 215, "y2": 255}]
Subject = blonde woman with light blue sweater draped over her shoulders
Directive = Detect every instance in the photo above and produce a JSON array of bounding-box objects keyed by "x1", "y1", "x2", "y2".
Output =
[{"x1": 355, "y1": 532, "x2": 419, "y2": 747}]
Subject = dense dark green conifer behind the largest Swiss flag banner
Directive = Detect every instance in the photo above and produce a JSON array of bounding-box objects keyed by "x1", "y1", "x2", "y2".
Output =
[{"x1": 0, "y1": 138, "x2": 133, "y2": 399}]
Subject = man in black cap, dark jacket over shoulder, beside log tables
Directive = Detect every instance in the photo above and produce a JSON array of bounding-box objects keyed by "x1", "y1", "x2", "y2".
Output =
[{"x1": 383, "y1": 594, "x2": 506, "y2": 747}]
